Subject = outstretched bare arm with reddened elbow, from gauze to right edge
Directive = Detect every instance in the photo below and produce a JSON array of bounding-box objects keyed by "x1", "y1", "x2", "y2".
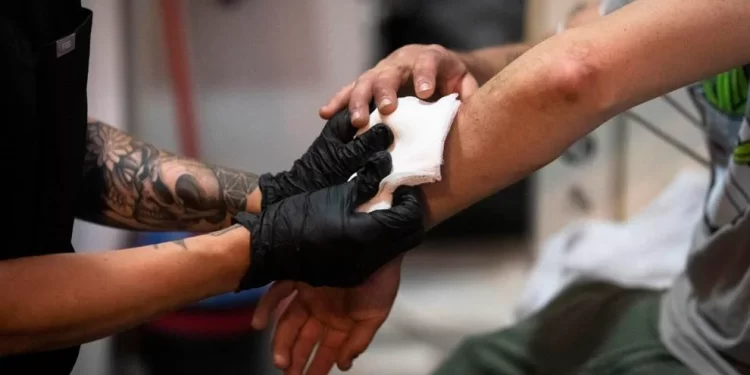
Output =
[{"x1": 424, "y1": 0, "x2": 750, "y2": 226}]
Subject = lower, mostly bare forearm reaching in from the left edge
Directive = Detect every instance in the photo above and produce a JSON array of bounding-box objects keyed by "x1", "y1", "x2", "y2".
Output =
[{"x1": 0, "y1": 226, "x2": 250, "y2": 355}]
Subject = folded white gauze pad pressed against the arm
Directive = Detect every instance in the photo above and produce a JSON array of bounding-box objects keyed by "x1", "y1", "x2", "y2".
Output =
[{"x1": 350, "y1": 94, "x2": 461, "y2": 212}]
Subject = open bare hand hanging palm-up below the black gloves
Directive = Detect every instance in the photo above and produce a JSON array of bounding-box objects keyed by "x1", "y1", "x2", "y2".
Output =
[{"x1": 253, "y1": 258, "x2": 402, "y2": 375}]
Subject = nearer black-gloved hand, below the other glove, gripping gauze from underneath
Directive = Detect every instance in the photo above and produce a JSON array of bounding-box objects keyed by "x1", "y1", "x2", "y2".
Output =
[{"x1": 234, "y1": 151, "x2": 424, "y2": 290}]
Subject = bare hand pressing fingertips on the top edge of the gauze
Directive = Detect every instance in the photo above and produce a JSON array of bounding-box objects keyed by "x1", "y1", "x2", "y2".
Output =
[{"x1": 320, "y1": 44, "x2": 478, "y2": 127}]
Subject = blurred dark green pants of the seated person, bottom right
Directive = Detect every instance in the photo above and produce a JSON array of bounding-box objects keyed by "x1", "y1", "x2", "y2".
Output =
[{"x1": 435, "y1": 284, "x2": 693, "y2": 375}]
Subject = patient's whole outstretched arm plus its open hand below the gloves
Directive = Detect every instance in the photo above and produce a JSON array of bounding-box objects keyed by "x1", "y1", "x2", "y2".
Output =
[{"x1": 256, "y1": 0, "x2": 750, "y2": 375}]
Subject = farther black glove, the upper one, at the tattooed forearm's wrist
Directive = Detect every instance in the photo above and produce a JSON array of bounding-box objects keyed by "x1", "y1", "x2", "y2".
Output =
[{"x1": 258, "y1": 110, "x2": 393, "y2": 209}]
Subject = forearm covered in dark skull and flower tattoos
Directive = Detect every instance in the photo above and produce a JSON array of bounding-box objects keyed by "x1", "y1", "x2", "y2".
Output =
[{"x1": 80, "y1": 120, "x2": 258, "y2": 232}]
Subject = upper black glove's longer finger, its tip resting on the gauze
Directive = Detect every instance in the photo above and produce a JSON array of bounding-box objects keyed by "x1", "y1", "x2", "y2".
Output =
[{"x1": 337, "y1": 124, "x2": 393, "y2": 175}]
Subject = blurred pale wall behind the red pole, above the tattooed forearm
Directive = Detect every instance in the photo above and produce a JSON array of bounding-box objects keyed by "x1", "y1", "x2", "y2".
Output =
[{"x1": 132, "y1": 0, "x2": 374, "y2": 173}]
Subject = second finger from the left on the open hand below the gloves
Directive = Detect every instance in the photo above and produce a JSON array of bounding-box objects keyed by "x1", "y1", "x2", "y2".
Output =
[{"x1": 273, "y1": 298, "x2": 310, "y2": 369}]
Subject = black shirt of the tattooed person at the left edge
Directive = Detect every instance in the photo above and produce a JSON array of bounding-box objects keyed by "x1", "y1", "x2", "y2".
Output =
[{"x1": 0, "y1": 0, "x2": 92, "y2": 375}]
